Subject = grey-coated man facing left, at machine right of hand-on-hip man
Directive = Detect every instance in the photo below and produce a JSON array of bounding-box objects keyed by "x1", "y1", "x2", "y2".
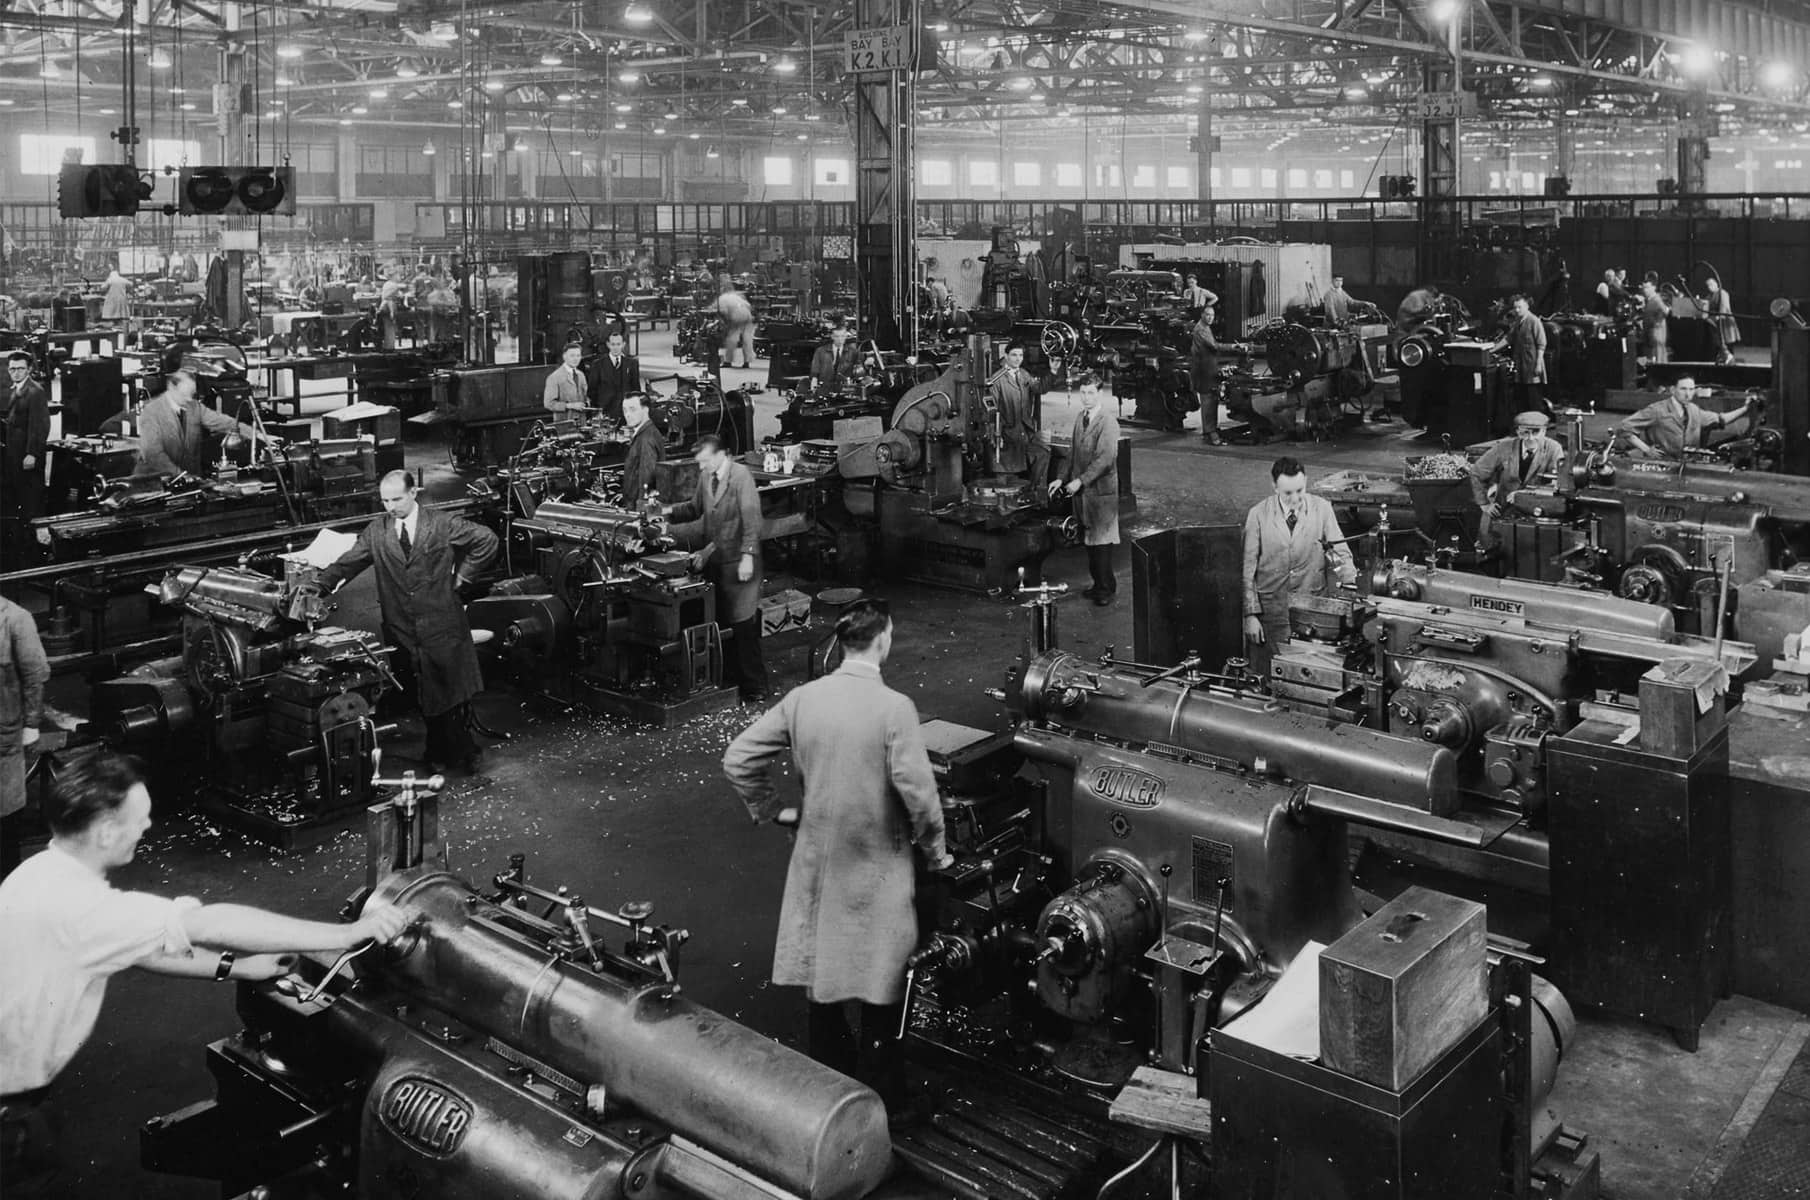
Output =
[{"x1": 666, "y1": 433, "x2": 767, "y2": 704}]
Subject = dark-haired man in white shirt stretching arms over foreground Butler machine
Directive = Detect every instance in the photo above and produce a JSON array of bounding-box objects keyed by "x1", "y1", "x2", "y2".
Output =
[{"x1": 0, "y1": 753, "x2": 409, "y2": 1196}]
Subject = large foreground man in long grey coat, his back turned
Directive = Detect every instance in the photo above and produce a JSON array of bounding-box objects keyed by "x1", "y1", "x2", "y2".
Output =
[{"x1": 722, "y1": 599, "x2": 950, "y2": 1108}]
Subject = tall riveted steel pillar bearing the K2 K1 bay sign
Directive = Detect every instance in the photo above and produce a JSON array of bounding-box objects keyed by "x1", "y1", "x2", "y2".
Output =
[{"x1": 854, "y1": 0, "x2": 919, "y2": 353}]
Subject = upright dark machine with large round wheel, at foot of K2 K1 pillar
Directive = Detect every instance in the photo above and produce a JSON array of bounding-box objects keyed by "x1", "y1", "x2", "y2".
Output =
[{"x1": 840, "y1": 335, "x2": 1062, "y2": 594}]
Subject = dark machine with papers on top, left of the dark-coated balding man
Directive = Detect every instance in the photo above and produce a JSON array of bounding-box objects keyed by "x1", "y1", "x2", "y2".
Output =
[{"x1": 89, "y1": 561, "x2": 396, "y2": 847}]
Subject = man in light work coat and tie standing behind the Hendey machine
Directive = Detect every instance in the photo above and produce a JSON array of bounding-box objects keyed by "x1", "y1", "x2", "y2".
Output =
[{"x1": 1243, "y1": 458, "x2": 1358, "y2": 679}]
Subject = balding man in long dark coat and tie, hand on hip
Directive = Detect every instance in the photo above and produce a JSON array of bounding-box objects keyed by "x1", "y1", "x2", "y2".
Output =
[{"x1": 320, "y1": 471, "x2": 496, "y2": 771}]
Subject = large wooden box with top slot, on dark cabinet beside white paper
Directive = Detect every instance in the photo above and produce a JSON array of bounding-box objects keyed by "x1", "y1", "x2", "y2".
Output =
[{"x1": 1319, "y1": 887, "x2": 1490, "y2": 1091}]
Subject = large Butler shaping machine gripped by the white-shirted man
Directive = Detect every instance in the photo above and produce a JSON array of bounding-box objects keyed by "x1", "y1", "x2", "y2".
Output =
[{"x1": 143, "y1": 778, "x2": 892, "y2": 1200}]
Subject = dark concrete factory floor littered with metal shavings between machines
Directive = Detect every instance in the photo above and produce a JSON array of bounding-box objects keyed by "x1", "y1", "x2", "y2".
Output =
[{"x1": 31, "y1": 323, "x2": 1810, "y2": 1200}]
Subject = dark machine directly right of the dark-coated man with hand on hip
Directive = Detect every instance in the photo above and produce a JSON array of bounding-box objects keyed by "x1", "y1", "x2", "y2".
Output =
[{"x1": 467, "y1": 500, "x2": 737, "y2": 726}]
